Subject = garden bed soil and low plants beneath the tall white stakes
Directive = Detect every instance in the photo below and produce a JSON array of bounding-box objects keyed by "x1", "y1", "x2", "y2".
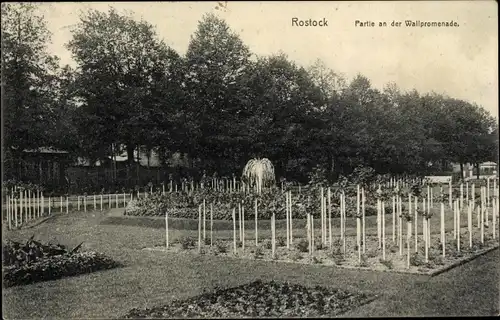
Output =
[{"x1": 144, "y1": 231, "x2": 499, "y2": 275}]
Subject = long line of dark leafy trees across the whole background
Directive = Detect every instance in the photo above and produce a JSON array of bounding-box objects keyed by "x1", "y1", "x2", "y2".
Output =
[{"x1": 2, "y1": 3, "x2": 498, "y2": 185}]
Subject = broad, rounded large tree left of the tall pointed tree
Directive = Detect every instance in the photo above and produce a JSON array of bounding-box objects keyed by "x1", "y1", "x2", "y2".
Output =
[{"x1": 68, "y1": 8, "x2": 182, "y2": 172}]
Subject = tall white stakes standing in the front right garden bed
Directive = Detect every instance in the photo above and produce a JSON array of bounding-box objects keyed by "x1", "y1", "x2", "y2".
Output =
[{"x1": 165, "y1": 182, "x2": 499, "y2": 268}]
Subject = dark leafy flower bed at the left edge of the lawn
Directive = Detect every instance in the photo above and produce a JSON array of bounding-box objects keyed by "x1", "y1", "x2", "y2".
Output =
[{"x1": 2, "y1": 238, "x2": 119, "y2": 287}]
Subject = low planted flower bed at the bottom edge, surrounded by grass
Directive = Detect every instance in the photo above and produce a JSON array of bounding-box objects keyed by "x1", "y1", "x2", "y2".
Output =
[{"x1": 125, "y1": 280, "x2": 374, "y2": 319}]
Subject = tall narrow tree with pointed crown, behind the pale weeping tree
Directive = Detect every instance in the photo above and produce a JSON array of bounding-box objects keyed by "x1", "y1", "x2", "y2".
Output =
[{"x1": 186, "y1": 14, "x2": 251, "y2": 171}]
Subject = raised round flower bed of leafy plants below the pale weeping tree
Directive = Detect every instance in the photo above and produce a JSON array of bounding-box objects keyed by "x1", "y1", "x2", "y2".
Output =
[{"x1": 125, "y1": 190, "x2": 378, "y2": 220}]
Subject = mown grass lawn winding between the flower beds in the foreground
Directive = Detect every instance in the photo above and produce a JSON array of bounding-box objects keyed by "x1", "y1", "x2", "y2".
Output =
[{"x1": 2, "y1": 208, "x2": 500, "y2": 319}]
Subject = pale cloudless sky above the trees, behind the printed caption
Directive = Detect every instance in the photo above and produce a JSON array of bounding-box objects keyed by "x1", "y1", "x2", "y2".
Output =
[{"x1": 40, "y1": 1, "x2": 498, "y2": 119}]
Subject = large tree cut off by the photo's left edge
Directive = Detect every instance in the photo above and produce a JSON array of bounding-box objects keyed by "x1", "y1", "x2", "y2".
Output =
[{"x1": 1, "y1": 3, "x2": 58, "y2": 158}]
